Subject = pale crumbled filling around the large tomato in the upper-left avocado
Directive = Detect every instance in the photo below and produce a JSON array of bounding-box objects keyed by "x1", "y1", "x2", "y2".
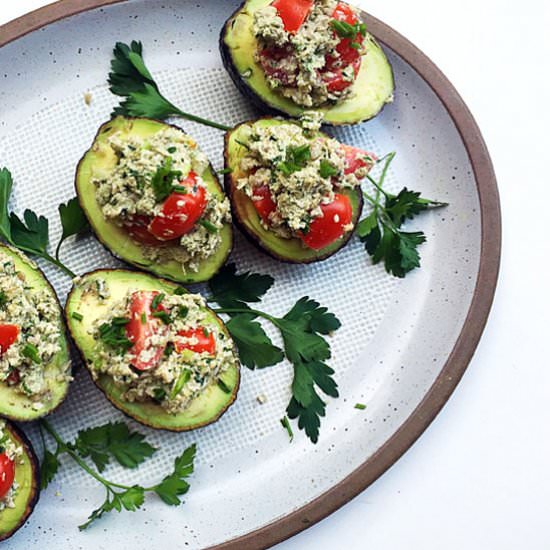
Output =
[{"x1": 92, "y1": 127, "x2": 231, "y2": 273}]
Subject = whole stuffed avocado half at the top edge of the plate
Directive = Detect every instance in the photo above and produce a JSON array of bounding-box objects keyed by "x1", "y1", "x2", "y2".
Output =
[{"x1": 220, "y1": 0, "x2": 395, "y2": 125}]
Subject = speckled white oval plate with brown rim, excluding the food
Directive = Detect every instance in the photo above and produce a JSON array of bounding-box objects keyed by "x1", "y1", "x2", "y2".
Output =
[{"x1": 0, "y1": 0, "x2": 500, "y2": 550}]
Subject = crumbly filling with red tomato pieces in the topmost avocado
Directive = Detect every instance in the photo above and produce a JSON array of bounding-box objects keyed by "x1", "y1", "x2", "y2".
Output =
[{"x1": 253, "y1": 0, "x2": 366, "y2": 107}]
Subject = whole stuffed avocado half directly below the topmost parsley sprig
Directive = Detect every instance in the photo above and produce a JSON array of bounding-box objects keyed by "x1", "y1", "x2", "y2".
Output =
[{"x1": 76, "y1": 117, "x2": 232, "y2": 283}]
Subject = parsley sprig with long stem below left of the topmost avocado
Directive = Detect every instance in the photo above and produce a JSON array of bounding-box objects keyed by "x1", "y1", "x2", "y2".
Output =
[{"x1": 109, "y1": 40, "x2": 231, "y2": 131}]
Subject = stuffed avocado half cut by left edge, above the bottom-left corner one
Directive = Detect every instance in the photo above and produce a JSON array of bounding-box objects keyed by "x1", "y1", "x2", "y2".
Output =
[{"x1": 0, "y1": 245, "x2": 72, "y2": 421}]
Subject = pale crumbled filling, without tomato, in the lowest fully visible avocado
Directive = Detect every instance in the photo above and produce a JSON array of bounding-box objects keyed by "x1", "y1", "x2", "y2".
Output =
[{"x1": 90, "y1": 289, "x2": 237, "y2": 414}]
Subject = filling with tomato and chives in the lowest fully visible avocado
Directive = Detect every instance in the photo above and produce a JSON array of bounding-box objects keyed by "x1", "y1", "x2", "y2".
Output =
[{"x1": 91, "y1": 289, "x2": 237, "y2": 414}]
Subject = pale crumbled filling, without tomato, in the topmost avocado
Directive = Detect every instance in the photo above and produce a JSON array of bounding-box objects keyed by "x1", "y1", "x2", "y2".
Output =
[{"x1": 253, "y1": 0, "x2": 366, "y2": 107}]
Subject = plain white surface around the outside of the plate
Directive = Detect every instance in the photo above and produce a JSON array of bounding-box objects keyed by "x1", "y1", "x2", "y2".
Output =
[{"x1": 0, "y1": 0, "x2": 550, "y2": 550}]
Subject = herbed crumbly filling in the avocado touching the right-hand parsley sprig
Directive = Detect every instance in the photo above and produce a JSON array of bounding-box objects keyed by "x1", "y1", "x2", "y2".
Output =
[{"x1": 237, "y1": 118, "x2": 374, "y2": 238}]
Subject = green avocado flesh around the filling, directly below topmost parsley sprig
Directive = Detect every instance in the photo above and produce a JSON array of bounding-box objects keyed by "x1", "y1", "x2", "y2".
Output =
[{"x1": 75, "y1": 117, "x2": 233, "y2": 283}]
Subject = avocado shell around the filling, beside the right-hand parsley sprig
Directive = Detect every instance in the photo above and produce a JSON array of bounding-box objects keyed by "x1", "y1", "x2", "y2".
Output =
[{"x1": 224, "y1": 117, "x2": 363, "y2": 264}]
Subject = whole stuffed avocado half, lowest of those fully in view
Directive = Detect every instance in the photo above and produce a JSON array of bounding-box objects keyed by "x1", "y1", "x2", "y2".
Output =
[{"x1": 66, "y1": 270, "x2": 240, "y2": 431}]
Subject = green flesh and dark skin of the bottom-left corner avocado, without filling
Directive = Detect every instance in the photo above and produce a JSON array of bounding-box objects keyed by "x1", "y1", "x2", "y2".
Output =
[{"x1": 0, "y1": 422, "x2": 40, "y2": 541}]
